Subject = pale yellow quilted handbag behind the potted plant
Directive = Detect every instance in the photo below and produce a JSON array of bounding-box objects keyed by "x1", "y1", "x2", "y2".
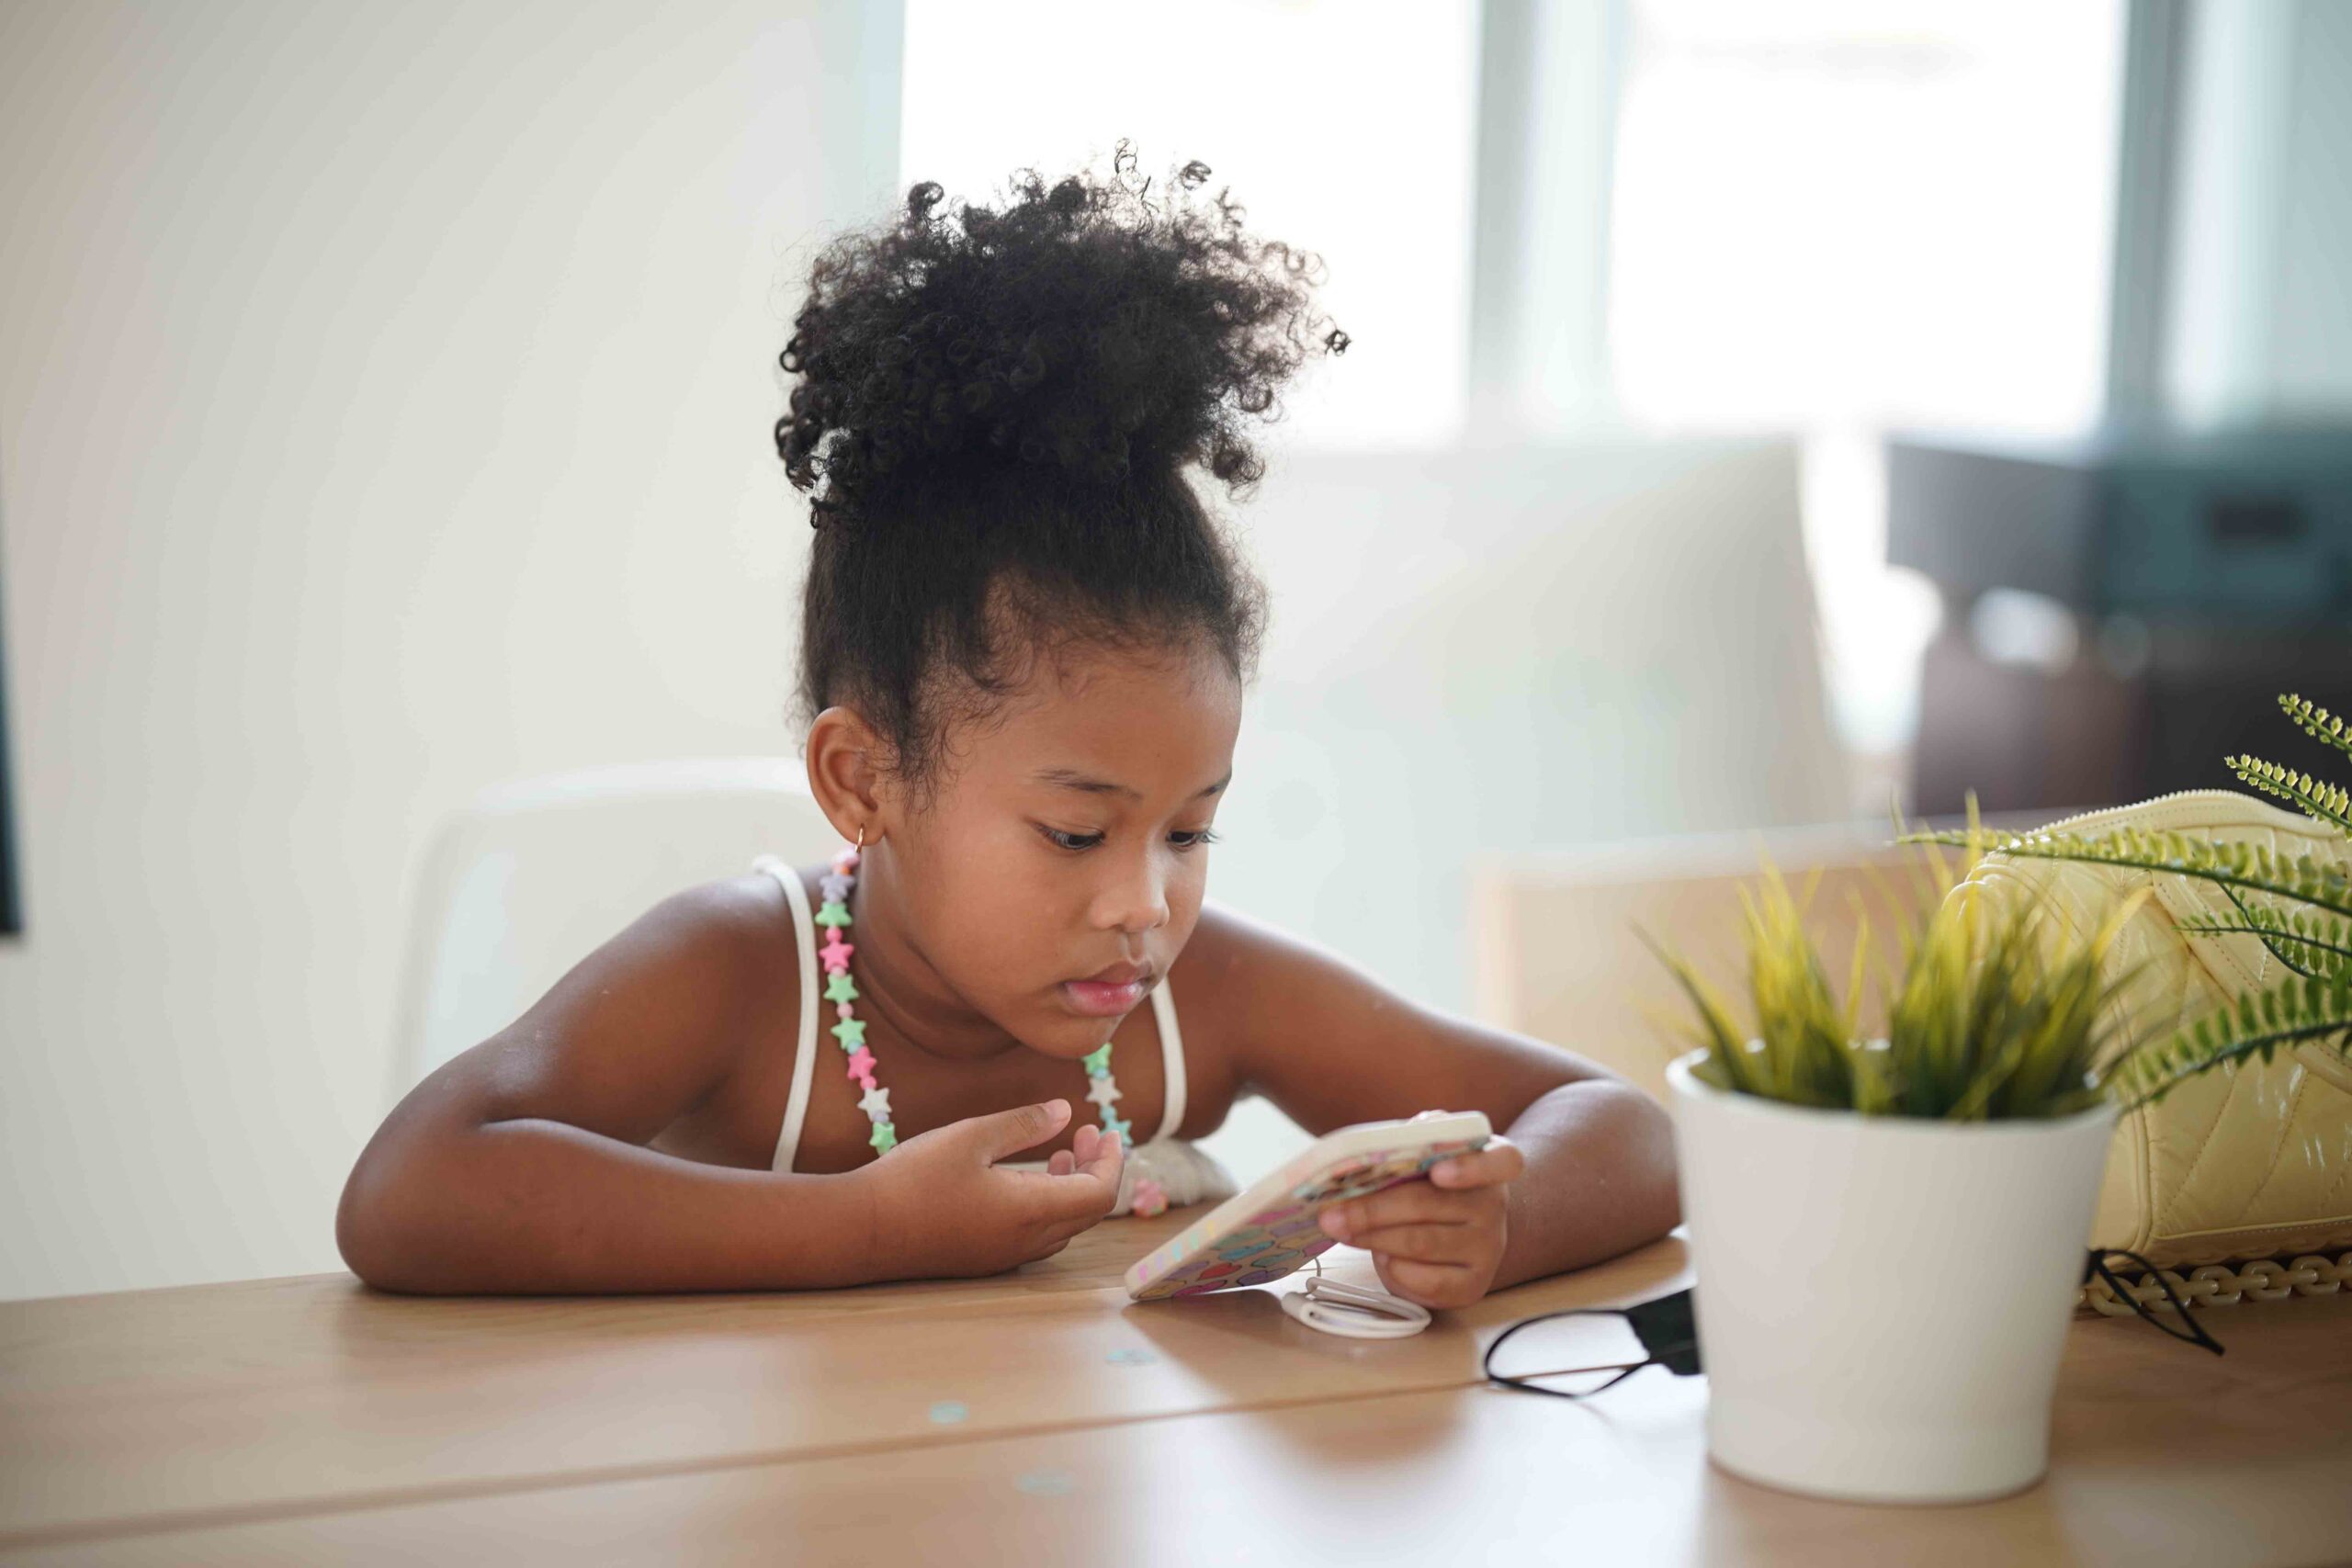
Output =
[{"x1": 1971, "y1": 790, "x2": 2352, "y2": 1309}]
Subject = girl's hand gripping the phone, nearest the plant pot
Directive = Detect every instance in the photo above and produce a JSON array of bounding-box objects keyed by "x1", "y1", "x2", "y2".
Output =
[{"x1": 1322, "y1": 1135, "x2": 1526, "y2": 1307}]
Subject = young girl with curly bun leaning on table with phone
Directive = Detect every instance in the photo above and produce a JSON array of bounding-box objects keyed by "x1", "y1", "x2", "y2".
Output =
[{"x1": 336, "y1": 143, "x2": 1677, "y2": 1307}]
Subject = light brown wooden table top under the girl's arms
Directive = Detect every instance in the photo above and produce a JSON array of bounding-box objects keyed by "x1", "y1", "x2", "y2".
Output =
[{"x1": 0, "y1": 1213, "x2": 2352, "y2": 1568}]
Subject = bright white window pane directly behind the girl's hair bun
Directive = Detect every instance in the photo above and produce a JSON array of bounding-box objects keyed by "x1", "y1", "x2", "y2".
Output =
[{"x1": 899, "y1": 0, "x2": 1477, "y2": 446}]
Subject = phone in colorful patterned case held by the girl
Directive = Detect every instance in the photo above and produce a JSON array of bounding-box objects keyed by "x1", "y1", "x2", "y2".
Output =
[{"x1": 1126, "y1": 1110, "x2": 1494, "y2": 1303}]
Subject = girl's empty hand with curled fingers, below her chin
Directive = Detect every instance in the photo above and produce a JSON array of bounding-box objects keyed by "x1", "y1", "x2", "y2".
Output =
[{"x1": 858, "y1": 1100, "x2": 1126, "y2": 1279}]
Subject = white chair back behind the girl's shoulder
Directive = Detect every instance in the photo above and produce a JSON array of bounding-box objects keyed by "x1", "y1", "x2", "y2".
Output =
[{"x1": 393, "y1": 757, "x2": 840, "y2": 1100}]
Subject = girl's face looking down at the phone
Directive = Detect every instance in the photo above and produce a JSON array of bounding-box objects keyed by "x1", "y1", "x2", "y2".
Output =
[{"x1": 887, "y1": 649, "x2": 1242, "y2": 1058}]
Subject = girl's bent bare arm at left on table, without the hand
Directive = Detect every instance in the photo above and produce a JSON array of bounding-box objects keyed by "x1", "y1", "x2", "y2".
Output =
[{"x1": 336, "y1": 877, "x2": 875, "y2": 1293}]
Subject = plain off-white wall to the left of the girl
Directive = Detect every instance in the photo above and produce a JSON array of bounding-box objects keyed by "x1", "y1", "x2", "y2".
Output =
[{"x1": 0, "y1": 0, "x2": 896, "y2": 1295}]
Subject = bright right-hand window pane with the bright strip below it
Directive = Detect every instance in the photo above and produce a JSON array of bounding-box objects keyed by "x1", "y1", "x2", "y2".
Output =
[{"x1": 1606, "y1": 0, "x2": 2124, "y2": 752}]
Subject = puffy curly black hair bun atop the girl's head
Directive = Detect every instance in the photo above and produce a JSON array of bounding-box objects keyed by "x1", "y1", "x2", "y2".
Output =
[{"x1": 776, "y1": 141, "x2": 1348, "y2": 522}]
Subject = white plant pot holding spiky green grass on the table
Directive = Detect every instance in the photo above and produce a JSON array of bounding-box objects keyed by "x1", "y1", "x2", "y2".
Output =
[{"x1": 1665, "y1": 1051, "x2": 2117, "y2": 1502}]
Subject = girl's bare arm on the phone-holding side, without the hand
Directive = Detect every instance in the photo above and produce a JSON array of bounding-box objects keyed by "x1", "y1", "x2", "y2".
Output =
[{"x1": 1188, "y1": 903, "x2": 1681, "y2": 1291}]
